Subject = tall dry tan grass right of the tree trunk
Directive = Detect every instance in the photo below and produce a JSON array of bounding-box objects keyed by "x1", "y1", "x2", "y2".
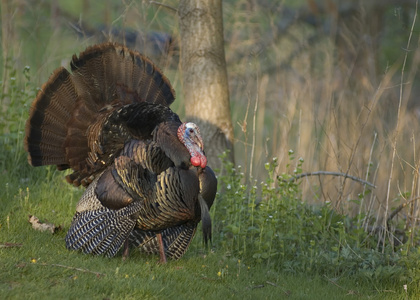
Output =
[{"x1": 225, "y1": 1, "x2": 420, "y2": 250}]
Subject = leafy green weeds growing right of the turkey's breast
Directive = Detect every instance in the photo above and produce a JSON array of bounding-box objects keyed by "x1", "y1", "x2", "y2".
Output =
[{"x1": 213, "y1": 150, "x2": 420, "y2": 284}]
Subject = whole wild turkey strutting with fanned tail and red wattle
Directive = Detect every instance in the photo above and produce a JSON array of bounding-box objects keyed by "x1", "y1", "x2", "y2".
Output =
[{"x1": 25, "y1": 43, "x2": 217, "y2": 261}]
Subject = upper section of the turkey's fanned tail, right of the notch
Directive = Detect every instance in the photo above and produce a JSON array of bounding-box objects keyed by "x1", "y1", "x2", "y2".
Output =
[{"x1": 70, "y1": 43, "x2": 175, "y2": 107}]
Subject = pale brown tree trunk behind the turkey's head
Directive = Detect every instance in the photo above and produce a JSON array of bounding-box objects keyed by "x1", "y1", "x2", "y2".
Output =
[{"x1": 178, "y1": 0, "x2": 234, "y2": 168}]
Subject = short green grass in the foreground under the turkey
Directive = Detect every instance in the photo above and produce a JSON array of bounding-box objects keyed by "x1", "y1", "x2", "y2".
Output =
[{"x1": 0, "y1": 212, "x2": 418, "y2": 299}]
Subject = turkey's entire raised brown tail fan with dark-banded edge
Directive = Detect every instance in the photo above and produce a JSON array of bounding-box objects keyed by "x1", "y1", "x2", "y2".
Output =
[{"x1": 25, "y1": 43, "x2": 175, "y2": 178}]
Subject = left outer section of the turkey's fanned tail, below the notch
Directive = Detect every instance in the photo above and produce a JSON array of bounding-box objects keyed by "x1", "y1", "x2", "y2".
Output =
[{"x1": 24, "y1": 68, "x2": 77, "y2": 169}]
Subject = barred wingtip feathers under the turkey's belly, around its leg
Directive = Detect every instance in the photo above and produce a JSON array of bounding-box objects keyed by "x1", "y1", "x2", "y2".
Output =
[{"x1": 130, "y1": 222, "x2": 197, "y2": 260}]
